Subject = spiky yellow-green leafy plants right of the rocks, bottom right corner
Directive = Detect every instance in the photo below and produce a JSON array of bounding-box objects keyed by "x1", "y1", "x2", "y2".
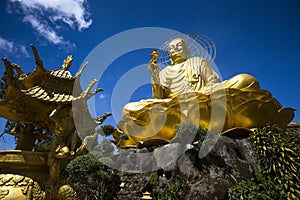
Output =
[{"x1": 229, "y1": 124, "x2": 300, "y2": 199}]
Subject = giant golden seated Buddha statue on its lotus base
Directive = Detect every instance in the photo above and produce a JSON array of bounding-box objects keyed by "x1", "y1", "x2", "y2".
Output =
[{"x1": 114, "y1": 38, "x2": 294, "y2": 147}]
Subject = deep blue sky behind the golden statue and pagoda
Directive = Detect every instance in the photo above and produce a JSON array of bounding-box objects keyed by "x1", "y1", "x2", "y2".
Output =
[{"x1": 0, "y1": 0, "x2": 300, "y2": 149}]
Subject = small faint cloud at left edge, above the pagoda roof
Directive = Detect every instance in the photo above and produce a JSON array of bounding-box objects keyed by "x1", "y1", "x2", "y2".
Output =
[{"x1": 0, "y1": 37, "x2": 29, "y2": 57}]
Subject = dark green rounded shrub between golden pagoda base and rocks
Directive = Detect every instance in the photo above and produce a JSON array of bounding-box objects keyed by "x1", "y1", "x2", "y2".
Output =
[{"x1": 66, "y1": 154, "x2": 111, "y2": 199}]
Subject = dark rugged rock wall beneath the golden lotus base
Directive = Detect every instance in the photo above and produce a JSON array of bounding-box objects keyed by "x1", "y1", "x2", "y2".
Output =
[{"x1": 115, "y1": 136, "x2": 258, "y2": 200}]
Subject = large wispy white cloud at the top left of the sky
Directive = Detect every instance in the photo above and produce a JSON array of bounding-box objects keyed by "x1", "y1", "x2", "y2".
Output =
[{"x1": 7, "y1": 0, "x2": 92, "y2": 45}]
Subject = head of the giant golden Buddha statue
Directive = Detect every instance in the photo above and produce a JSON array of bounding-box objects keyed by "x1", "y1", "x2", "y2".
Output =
[{"x1": 168, "y1": 38, "x2": 190, "y2": 64}]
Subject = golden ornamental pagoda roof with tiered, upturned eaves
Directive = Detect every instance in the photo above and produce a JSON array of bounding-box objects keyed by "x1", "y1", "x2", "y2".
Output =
[{"x1": 0, "y1": 46, "x2": 102, "y2": 129}]
